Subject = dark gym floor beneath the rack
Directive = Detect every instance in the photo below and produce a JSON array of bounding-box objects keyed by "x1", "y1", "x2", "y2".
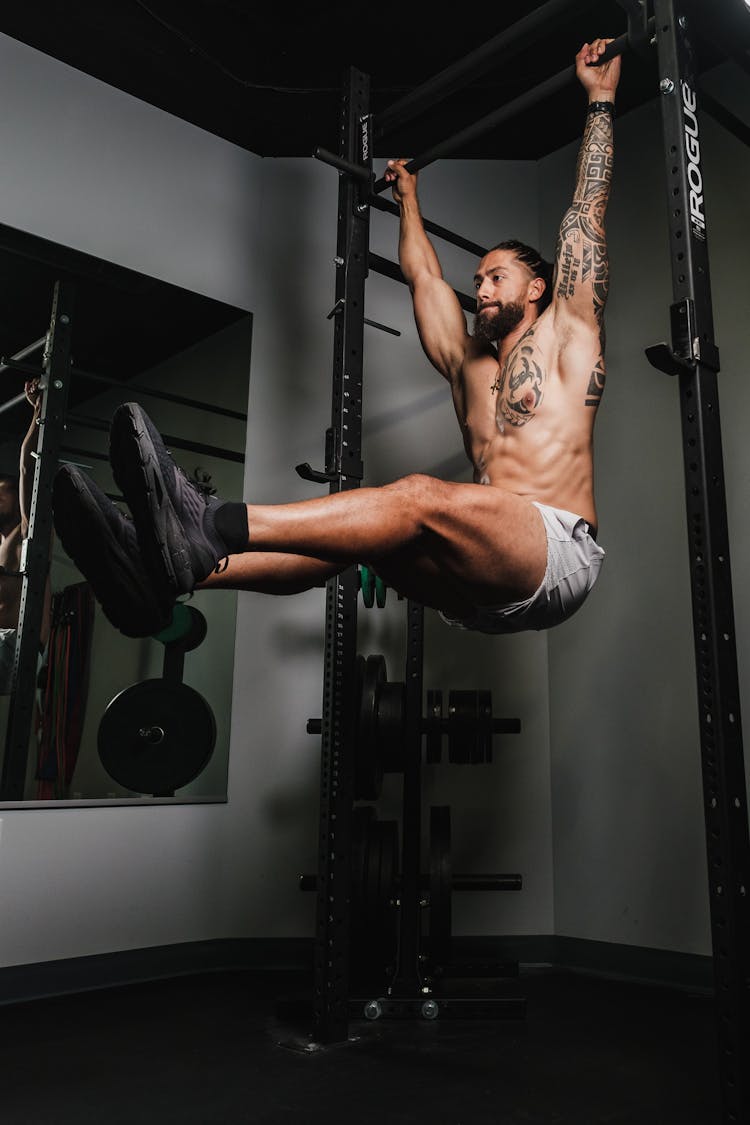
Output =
[{"x1": 0, "y1": 971, "x2": 721, "y2": 1125}]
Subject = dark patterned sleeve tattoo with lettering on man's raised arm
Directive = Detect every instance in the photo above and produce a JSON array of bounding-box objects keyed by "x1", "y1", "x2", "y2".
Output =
[{"x1": 554, "y1": 110, "x2": 614, "y2": 326}]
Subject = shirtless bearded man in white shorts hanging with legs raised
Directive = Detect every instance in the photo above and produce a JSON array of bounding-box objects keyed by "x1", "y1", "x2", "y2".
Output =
[{"x1": 53, "y1": 39, "x2": 620, "y2": 636}]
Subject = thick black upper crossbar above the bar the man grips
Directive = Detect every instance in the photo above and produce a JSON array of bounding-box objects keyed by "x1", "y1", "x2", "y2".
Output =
[{"x1": 374, "y1": 0, "x2": 588, "y2": 137}]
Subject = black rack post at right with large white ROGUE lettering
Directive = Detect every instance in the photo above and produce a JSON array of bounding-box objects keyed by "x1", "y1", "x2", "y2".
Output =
[{"x1": 647, "y1": 0, "x2": 750, "y2": 1123}]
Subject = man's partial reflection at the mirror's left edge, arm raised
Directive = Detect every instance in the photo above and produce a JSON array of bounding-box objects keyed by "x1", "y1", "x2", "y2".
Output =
[{"x1": 0, "y1": 379, "x2": 49, "y2": 695}]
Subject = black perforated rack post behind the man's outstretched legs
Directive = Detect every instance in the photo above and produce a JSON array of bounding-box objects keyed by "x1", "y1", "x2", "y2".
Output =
[{"x1": 308, "y1": 69, "x2": 371, "y2": 1043}]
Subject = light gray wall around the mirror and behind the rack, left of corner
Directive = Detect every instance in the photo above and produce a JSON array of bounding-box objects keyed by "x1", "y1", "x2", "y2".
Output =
[{"x1": 0, "y1": 37, "x2": 552, "y2": 965}]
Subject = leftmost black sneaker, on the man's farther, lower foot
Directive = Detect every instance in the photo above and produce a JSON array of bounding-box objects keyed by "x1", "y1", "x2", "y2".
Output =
[{"x1": 52, "y1": 465, "x2": 173, "y2": 637}]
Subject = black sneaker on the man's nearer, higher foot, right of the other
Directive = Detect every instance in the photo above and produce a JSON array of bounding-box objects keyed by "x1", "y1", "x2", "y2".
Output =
[{"x1": 109, "y1": 403, "x2": 229, "y2": 597}]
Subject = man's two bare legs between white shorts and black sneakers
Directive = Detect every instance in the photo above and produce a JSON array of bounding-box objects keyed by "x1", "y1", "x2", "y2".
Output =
[{"x1": 205, "y1": 476, "x2": 546, "y2": 608}]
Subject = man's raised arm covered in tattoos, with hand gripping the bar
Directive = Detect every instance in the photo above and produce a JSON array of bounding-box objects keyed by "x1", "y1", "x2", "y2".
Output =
[{"x1": 552, "y1": 39, "x2": 620, "y2": 333}]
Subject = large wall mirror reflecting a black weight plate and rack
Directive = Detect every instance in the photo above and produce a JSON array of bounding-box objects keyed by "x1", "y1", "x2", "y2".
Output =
[{"x1": 0, "y1": 226, "x2": 252, "y2": 807}]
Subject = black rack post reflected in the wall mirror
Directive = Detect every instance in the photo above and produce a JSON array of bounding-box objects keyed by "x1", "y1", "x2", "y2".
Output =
[{"x1": 0, "y1": 281, "x2": 73, "y2": 801}]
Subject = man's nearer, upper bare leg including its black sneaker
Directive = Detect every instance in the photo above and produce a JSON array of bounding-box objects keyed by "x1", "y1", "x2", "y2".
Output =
[{"x1": 110, "y1": 403, "x2": 546, "y2": 606}]
